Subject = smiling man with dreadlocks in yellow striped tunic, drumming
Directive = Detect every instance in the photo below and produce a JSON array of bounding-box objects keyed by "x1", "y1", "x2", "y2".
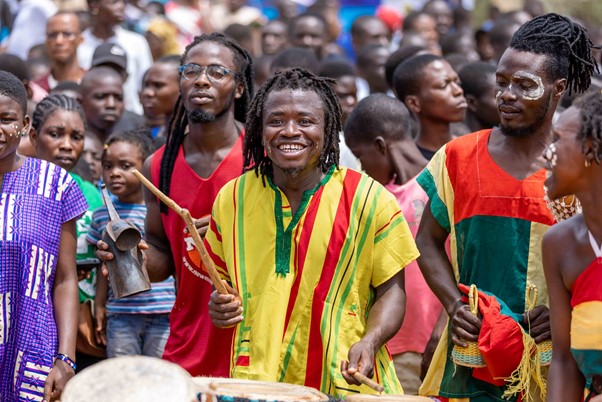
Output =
[{"x1": 205, "y1": 68, "x2": 418, "y2": 396}]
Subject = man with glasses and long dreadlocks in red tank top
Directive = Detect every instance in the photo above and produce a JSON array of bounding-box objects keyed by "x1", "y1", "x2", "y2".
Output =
[{"x1": 98, "y1": 33, "x2": 253, "y2": 377}]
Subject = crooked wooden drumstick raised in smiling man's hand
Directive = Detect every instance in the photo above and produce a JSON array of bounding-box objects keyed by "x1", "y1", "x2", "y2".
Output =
[{"x1": 131, "y1": 169, "x2": 228, "y2": 295}]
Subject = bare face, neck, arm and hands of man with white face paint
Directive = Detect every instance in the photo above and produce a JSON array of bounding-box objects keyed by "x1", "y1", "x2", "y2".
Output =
[{"x1": 416, "y1": 49, "x2": 566, "y2": 346}]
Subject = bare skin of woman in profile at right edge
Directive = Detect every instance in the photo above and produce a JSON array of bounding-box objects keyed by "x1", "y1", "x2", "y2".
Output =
[{"x1": 542, "y1": 107, "x2": 602, "y2": 402}]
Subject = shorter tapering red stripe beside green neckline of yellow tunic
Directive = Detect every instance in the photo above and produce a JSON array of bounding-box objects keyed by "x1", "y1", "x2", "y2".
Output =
[{"x1": 282, "y1": 186, "x2": 324, "y2": 337}]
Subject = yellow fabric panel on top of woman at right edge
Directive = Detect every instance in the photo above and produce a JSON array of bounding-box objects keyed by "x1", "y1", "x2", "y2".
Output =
[{"x1": 571, "y1": 301, "x2": 602, "y2": 350}]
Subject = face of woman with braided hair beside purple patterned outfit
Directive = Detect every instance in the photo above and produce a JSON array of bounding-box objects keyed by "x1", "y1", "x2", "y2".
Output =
[{"x1": 30, "y1": 109, "x2": 85, "y2": 171}]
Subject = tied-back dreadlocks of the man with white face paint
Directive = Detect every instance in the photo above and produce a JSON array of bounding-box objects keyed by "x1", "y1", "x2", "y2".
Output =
[{"x1": 509, "y1": 13, "x2": 598, "y2": 94}]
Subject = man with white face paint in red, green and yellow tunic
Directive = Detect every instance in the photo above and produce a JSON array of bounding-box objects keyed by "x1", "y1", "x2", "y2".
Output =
[{"x1": 416, "y1": 14, "x2": 596, "y2": 402}]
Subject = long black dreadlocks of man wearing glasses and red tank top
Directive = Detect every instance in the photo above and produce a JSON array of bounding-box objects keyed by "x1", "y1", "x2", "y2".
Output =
[{"x1": 159, "y1": 32, "x2": 254, "y2": 213}]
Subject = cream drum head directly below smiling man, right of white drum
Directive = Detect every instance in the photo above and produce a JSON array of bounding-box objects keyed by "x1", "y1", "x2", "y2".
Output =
[{"x1": 193, "y1": 377, "x2": 330, "y2": 402}]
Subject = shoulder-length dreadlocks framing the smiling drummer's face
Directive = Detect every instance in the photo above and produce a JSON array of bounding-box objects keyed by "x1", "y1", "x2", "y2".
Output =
[{"x1": 243, "y1": 68, "x2": 342, "y2": 185}]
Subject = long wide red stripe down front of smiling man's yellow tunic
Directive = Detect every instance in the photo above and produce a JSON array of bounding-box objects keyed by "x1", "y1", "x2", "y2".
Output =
[{"x1": 305, "y1": 170, "x2": 362, "y2": 389}]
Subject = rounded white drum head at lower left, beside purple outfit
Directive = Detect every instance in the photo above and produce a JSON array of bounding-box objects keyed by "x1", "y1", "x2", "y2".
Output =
[{"x1": 61, "y1": 356, "x2": 197, "y2": 402}]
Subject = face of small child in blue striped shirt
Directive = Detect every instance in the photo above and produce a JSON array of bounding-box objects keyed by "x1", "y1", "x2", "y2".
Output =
[{"x1": 102, "y1": 141, "x2": 144, "y2": 204}]
